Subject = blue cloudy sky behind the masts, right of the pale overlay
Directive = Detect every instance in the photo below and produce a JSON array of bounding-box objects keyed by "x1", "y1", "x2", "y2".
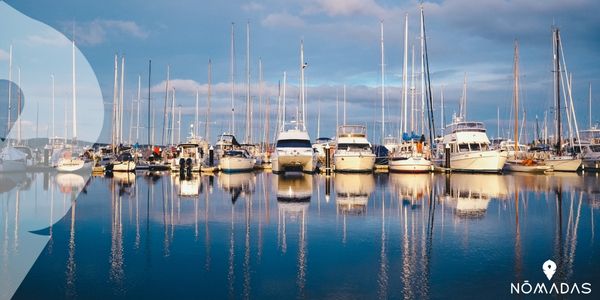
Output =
[{"x1": 0, "y1": 0, "x2": 600, "y2": 143}]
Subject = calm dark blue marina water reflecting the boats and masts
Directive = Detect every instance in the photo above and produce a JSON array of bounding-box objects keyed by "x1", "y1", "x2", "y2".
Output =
[{"x1": 1, "y1": 173, "x2": 600, "y2": 299}]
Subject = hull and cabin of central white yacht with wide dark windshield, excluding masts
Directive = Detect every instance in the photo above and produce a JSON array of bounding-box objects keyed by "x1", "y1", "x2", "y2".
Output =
[{"x1": 271, "y1": 127, "x2": 316, "y2": 173}]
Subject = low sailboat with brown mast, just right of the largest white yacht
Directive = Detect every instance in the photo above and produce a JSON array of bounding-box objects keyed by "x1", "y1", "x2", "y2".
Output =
[{"x1": 504, "y1": 41, "x2": 552, "y2": 173}]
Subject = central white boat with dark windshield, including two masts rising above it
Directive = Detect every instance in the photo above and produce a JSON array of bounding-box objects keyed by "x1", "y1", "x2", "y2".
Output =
[{"x1": 271, "y1": 42, "x2": 316, "y2": 173}]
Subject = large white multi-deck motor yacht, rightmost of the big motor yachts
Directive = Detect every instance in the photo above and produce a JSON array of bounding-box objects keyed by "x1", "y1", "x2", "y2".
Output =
[{"x1": 435, "y1": 117, "x2": 508, "y2": 173}]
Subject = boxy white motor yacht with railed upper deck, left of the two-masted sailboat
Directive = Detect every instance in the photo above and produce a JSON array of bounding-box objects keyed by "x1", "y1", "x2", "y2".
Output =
[{"x1": 333, "y1": 125, "x2": 375, "y2": 172}]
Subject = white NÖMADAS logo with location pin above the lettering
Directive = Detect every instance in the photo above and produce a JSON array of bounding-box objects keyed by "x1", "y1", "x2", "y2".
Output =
[{"x1": 510, "y1": 259, "x2": 592, "y2": 295}]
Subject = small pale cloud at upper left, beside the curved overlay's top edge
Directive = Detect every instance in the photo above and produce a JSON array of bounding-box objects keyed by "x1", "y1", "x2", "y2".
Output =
[{"x1": 65, "y1": 19, "x2": 149, "y2": 45}]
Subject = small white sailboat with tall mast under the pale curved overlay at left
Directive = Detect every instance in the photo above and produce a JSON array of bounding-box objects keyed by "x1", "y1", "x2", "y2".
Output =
[{"x1": 55, "y1": 40, "x2": 93, "y2": 172}]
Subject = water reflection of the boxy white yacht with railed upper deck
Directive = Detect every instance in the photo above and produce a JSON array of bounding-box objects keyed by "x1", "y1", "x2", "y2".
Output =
[{"x1": 333, "y1": 173, "x2": 375, "y2": 215}]
